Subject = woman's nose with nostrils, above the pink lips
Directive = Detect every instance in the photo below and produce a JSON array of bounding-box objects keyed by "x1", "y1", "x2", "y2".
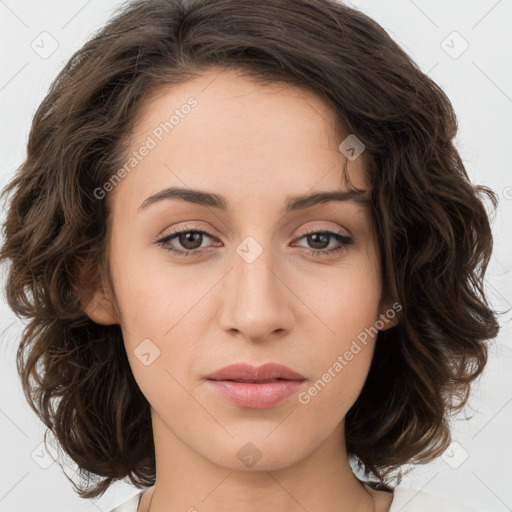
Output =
[{"x1": 220, "y1": 241, "x2": 294, "y2": 341}]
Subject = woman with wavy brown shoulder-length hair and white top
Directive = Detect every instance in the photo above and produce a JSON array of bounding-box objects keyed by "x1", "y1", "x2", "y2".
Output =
[{"x1": 1, "y1": 0, "x2": 498, "y2": 512}]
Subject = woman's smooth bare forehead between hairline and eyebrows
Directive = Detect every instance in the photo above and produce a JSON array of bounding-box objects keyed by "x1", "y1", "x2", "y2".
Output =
[{"x1": 110, "y1": 70, "x2": 368, "y2": 215}]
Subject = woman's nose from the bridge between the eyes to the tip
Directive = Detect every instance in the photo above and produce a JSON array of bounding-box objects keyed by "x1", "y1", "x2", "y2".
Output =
[{"x1": 221, "y1": 236, "x2": 291, "y2": 339}]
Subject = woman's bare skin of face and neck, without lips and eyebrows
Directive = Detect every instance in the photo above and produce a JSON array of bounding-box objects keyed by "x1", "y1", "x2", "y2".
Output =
[{"x1": 85, "y1": 69, "x2": 395, "y2": 512}]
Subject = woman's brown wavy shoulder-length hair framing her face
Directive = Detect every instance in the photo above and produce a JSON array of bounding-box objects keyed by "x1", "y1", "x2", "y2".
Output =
[{"x1": 0, "y1": 0, "x2": 499, "y2": 498}]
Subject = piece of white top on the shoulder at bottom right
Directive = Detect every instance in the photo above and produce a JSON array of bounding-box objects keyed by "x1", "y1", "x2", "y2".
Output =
[{"x1": 389, "y1": 485, "x2": 477, "y2": 512}]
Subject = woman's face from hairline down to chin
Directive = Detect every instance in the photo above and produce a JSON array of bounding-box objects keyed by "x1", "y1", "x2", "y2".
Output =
[{"x1": 87, "y1": 67, "x2": 393, "y2": 469}]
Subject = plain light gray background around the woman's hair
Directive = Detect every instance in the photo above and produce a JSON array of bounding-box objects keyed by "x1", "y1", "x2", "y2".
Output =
[{"x1": 0, "y1": 0, "x2": 512, "y2": 512}]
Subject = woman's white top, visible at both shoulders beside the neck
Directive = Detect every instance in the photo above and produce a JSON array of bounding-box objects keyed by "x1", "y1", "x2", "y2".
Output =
[{"x1": 110, "y1": 485, "x2": 478, "y2": 512}]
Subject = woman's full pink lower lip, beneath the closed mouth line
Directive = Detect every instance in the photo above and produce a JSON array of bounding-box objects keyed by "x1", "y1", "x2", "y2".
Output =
[{"x1": 206, "y1": 379, "x2": 305, "y2": 409}]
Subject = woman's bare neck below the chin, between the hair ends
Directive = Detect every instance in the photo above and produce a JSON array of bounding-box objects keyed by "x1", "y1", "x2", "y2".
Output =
[{"x1": 144, "y1": 411, "x2": 375, "y2": 512}]
